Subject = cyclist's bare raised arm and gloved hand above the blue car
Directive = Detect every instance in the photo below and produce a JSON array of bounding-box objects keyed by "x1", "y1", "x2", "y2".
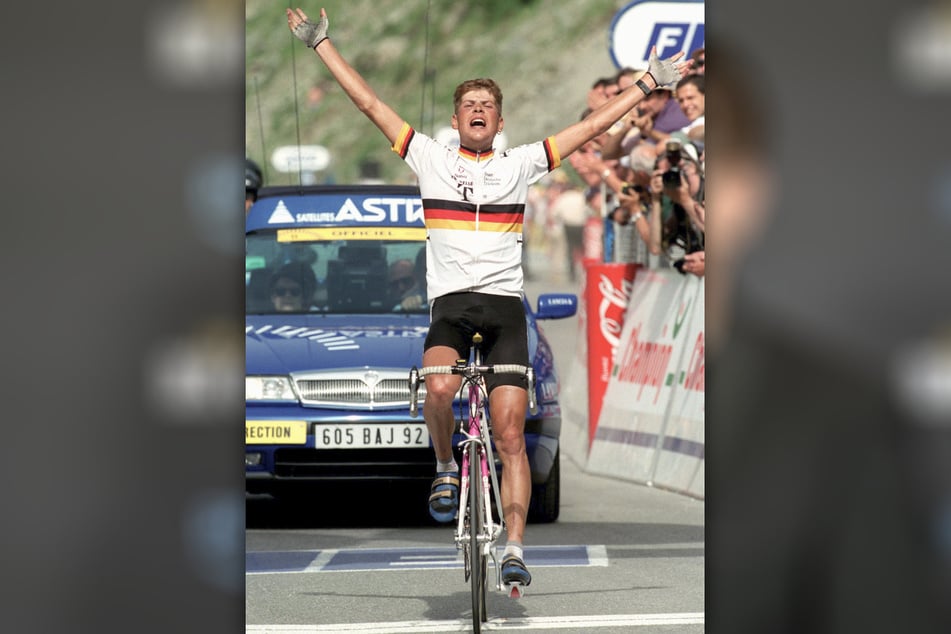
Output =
[{"x1": 286, "y1": 8, "x2": 403, "y2": 143}]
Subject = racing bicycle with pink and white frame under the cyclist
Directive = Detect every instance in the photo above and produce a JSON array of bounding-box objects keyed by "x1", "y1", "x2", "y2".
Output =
[{"x1": 409, "y1": 333, "x2": 538, "y2": 633}]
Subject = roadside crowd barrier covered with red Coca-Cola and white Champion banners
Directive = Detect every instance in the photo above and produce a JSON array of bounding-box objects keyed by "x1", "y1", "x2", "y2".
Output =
[{"x1": 562, "y1": 260, "x2": 704, "y2": 499}]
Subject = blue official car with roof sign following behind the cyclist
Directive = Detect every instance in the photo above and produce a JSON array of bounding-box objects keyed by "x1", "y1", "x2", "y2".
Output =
[{"x1": 245, "y1": 185, "x2": 578, "y2": 522}]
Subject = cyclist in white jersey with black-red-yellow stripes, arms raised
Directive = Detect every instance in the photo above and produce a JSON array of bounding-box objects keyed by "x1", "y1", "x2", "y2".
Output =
[{"x1": 286, "y1": 8, "x2": 692, "y2": 586}]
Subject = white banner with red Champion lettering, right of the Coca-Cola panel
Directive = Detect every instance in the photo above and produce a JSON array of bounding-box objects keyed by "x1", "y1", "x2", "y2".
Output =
[{"x1": 587, "y1": 270, "x2": 704, "y2": 497}]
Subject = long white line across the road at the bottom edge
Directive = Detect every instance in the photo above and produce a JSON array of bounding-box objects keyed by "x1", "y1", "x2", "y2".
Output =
[{"x1": 245, "y1": 612, "x2": 704, "y2": 634}]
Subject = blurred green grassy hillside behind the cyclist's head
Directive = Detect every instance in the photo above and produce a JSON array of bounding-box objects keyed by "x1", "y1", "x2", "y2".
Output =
[{"x1": 245, "y1": 0, "x2": 626, "y2": 185}]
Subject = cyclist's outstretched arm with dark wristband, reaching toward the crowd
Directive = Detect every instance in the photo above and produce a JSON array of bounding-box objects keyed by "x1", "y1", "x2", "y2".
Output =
[{"x1": 555, "y1": 47, "x2": 693, "y2": 159}]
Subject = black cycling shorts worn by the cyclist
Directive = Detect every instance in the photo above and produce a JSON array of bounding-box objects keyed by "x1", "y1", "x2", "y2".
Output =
[{"x1": 424, "y1": 293, "x2": 529, "y2": 392}]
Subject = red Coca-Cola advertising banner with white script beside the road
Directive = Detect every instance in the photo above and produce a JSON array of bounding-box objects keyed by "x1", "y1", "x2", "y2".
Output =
[{"x1": 584, "y1": 263, "x2": 640, "y2": 446}]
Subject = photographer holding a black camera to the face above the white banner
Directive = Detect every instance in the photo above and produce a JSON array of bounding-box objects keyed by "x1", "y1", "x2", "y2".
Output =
[{"x1": 649, "y1": 139, "x2": 704, "y2": 275}]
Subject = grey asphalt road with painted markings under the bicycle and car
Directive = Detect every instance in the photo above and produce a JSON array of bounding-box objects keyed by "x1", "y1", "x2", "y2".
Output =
[{"x1": 245, "y1": 266, "x2": 704, "y2": 634}]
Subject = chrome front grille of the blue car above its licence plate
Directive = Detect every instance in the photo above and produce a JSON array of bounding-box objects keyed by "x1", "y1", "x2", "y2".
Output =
[{"x1": 292, "y1": 369, "x2": 426, "y2": 410}]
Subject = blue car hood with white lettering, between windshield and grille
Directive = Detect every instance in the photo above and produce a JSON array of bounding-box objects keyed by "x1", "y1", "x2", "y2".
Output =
[{"x1": 245, "y1": 314, "x2": 429, "y2": 375}]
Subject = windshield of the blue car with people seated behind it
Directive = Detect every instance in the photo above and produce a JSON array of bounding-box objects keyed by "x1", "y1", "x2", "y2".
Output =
[{"x1": 245, "y1": 229, "x2": 429, "y2": 314}]
